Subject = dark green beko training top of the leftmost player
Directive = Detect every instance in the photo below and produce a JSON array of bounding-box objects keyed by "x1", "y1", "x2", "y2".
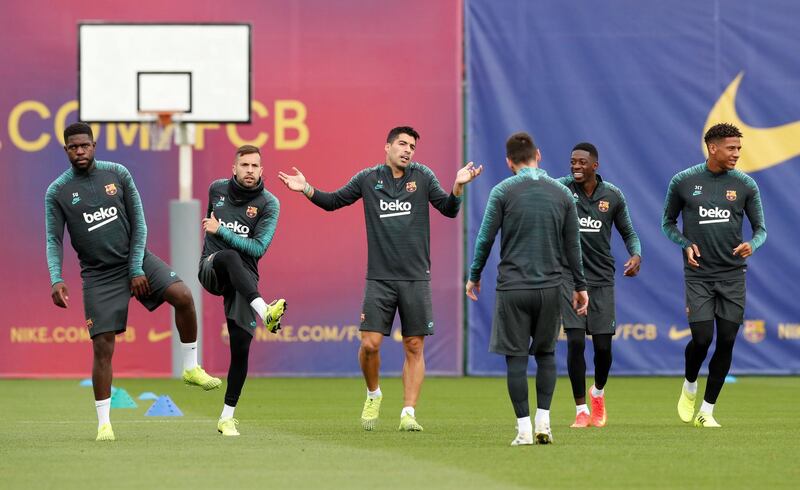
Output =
[{"x1": 44, "y1": 160, "x2": 147, "y2": 287}]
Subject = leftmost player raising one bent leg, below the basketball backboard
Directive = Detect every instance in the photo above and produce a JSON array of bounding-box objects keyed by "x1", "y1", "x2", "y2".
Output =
[{"x1": 45, "y1": 123, "x2": 221, "y2": 441}]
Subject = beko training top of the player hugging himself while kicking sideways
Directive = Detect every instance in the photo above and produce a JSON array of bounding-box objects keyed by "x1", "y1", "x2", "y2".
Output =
[{"x1": 200, "y1": 179, "x2": 281, "y2": 277}]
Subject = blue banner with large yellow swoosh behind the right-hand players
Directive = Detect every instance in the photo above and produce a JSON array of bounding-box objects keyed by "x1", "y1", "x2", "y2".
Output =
[{"x1": 465, "y1": 0, "x2": 800, "y2": 374}]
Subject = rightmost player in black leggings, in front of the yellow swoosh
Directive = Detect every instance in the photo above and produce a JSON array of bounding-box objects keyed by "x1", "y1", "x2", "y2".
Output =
[{"x1": 662, "y1": 123, "x2": 767, "y2": 427}]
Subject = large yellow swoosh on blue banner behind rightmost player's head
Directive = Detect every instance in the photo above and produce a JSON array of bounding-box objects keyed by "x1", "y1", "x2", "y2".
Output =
[{"x1": 702, "y1": 72, "x2": 800, "y2": 172}]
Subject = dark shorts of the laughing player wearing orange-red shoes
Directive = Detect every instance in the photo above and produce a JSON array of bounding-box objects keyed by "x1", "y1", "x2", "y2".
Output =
[{"x1": 561, "y1": 281, "x2": 617, "y2": 335}]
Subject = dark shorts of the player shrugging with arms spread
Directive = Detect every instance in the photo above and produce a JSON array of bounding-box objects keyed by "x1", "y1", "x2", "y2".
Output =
[{"x1": 359, "y1": 279, "x2": 433, "y2": 337}]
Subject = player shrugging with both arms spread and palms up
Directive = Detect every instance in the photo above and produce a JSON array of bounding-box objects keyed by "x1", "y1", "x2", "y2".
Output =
[{"x1": 278, "y1": 126, "x2": 483, "y2": 431}]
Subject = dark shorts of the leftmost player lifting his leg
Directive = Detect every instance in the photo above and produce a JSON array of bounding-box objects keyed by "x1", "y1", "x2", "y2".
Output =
[{"x1": 83, "y1": 251, "x2": 181, "y2": 337}]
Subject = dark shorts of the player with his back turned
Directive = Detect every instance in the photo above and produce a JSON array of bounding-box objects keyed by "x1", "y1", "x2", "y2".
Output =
[{"x1": 489, "y1": 287, "x2": 561, "y2": 356}]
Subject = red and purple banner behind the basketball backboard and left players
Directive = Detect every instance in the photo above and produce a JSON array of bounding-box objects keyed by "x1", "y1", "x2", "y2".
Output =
[{"x1": 0, "y1": 0, "x2": 463, "y2": 376}]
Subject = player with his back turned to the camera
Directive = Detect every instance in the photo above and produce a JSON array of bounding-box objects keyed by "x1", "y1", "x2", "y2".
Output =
[{"x1": 465, "y1": 133, "x2": 589, "y2": 446}]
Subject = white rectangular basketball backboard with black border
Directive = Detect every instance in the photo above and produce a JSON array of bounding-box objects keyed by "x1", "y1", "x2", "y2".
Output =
[{"x1": 78, "y1": 22, "x2": 252, "y2": 123}]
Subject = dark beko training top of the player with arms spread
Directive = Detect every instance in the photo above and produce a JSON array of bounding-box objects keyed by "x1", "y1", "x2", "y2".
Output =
[{"x1": 311, "y1": 163, "x2": 461, "y2": 281}]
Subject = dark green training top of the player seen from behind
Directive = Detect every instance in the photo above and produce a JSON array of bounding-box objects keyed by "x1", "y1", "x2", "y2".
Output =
[{"x1": 469, "y1": 167, "x2": 586, "y2": 291}]
